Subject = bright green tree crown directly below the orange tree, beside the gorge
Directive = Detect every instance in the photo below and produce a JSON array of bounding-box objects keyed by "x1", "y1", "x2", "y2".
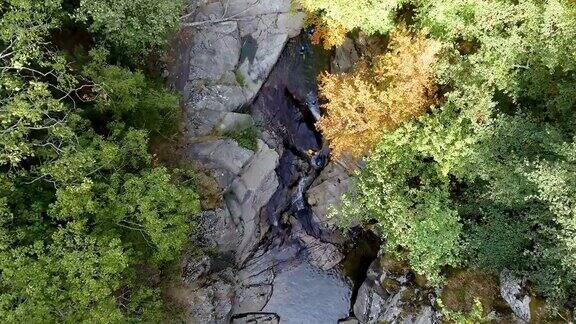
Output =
[{"x1": 341, "y1": 109, "x2": 462, "y2": 283}]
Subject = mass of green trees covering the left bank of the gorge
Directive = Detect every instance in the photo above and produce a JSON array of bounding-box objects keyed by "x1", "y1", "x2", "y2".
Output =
[{"x1": 0, "y1": 0, "x2": 199, "y2": 323}]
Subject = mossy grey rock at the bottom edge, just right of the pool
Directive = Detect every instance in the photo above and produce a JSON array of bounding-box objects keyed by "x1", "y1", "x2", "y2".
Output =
[{"x1": 354, "y1": 257, "x2": 439, "y2": 323}]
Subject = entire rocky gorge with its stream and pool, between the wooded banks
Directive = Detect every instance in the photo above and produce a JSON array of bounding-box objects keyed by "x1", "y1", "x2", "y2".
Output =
[{"x1": 166, "y1": 0, "x2": 536, "y2": 323}]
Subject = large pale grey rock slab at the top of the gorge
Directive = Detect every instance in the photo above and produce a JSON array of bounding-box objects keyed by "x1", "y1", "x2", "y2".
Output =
[{"x1": 180, "y1": 0, "x2": 304, "y2": 137}]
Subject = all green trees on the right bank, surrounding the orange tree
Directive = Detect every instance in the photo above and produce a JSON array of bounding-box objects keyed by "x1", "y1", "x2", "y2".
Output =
[{"x1": 322, "y1": 0, "x2": 576, "y2": 306}]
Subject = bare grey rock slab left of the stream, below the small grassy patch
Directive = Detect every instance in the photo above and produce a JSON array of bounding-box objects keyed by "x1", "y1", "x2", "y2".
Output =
[{"x1": 187, "y1": 139, "x2": 279, "y2": 264}]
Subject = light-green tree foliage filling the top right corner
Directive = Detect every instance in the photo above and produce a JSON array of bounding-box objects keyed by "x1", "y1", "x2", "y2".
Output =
[{"x1": 419, "y1": 0, "x2": 576, "y2": 121}]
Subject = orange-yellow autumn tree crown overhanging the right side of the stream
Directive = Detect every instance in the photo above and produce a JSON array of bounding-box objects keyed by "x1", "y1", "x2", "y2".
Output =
[{"x1": 317, "y1": 30, "x2": 440, "y2": 157}]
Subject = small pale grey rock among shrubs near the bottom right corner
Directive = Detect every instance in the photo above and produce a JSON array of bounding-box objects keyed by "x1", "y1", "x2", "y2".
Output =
[{"x1": 500, "y1": 271, "x2": 530, "y2": 323}]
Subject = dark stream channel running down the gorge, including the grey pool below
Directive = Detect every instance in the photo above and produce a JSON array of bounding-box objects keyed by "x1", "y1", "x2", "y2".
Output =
[{"x1": 247, "y1": 36, "x2": 379, "y2": 323}]
